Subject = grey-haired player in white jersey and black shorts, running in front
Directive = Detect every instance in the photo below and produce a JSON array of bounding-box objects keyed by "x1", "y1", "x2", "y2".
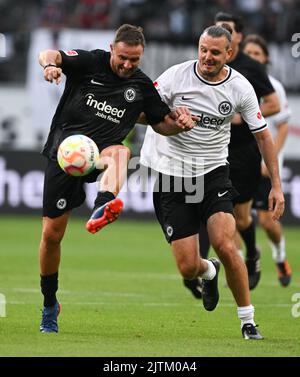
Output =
[{"x1": 141, "y1": 26, "x2": 284, "y2": 339}]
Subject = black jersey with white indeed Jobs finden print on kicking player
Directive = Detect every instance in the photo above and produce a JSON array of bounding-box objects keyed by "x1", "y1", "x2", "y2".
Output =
[{"x1": 43, "y1": 50, "x2": 170, "y2": 159}]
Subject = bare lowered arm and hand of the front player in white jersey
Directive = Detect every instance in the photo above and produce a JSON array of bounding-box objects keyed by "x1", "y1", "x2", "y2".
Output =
[{"x1": 254, "y1": 129, "x2": 284, "y2": 220}]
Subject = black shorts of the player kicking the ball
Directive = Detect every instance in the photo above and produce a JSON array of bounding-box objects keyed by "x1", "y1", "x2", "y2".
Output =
[{"x1": 43, "y1": 160, "x2": 101, "y2": 218}]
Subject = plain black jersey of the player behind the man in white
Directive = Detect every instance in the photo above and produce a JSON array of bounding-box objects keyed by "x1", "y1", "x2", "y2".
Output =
[{"x1": 228, "y1": 51, "x2": 274, "y2": 149}]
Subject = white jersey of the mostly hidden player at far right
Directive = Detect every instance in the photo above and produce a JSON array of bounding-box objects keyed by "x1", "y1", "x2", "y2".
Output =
[{"x1": 266, "y1": 75, "x2": 291, "y2": 173}]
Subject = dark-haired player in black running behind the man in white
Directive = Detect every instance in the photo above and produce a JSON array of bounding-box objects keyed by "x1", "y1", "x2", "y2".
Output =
[{"x1": 184, "y1": 12, "x2": 280, "y2": 298}]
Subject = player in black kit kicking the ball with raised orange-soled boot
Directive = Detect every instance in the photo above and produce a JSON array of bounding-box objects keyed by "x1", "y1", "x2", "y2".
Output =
[{"x1": 39, "y1": 24, "x2": 195, "y2": 333}]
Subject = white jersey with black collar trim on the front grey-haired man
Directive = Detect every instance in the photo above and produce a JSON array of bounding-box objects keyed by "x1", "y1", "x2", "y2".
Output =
[{"x1": 141, "y1": 60, "x2": 267, "y2": 177}]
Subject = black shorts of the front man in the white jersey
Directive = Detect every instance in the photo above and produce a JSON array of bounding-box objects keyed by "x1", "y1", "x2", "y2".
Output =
[{"x1": 153, "y1": 165, "x2": 238, "y2": 243}]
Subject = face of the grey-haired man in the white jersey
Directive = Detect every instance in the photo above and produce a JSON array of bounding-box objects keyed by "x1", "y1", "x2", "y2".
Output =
[{"x1": 199, "y1": 34, "x2": 232, "y2": 78}]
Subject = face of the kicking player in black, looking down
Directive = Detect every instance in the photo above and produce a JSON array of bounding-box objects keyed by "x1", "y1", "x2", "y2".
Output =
[{"x1": 110, "y1": 42, "x2": 144, "y2": 78}]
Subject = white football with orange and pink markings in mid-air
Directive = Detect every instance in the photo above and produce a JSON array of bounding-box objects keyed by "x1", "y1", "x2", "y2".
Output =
[{"x1": 57, "y1": 135, "x2": 99, "y2": 177}]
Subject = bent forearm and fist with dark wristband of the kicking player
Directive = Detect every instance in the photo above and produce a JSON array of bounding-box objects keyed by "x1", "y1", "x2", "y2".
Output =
[{"x1": 39, "y1": 50, "x2": 62, "y2": 85}]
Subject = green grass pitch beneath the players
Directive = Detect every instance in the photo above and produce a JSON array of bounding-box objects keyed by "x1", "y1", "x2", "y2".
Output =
[{"x1": 0, "y1": 216, "x2": 300, "y2": 357}]
